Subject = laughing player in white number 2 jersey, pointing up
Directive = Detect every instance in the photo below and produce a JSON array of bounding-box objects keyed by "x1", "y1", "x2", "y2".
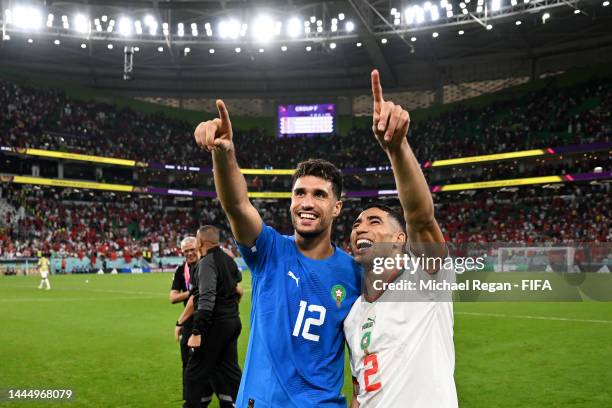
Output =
[{"x1": 344, "y1": 70, "x2": 458, "y2": 408}]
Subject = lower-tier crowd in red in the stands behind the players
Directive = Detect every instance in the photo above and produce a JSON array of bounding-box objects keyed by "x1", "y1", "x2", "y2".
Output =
[{"x1": 0, "y1": 183, "x2": 612, "y2": 259}]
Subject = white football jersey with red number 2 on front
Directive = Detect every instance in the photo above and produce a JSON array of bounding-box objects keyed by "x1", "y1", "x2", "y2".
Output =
[{"x1": 344, "y1": 262, "x2": 458, "y2": 408}]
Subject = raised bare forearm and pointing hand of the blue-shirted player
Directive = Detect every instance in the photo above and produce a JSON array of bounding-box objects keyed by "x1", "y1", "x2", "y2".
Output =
[{"x1": 195, "y1": 100, "x2": 263, "y2": 246}]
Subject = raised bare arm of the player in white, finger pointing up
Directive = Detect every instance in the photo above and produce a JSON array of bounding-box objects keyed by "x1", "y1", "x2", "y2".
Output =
[{"x1": 372, "y1": 70, "x2": 447, "y2": 273}]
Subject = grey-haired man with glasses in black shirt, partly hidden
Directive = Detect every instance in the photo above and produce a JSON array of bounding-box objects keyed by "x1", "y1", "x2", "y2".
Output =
[{"x1": 170, "y1": 236, "x2": 199, "y2": 399}]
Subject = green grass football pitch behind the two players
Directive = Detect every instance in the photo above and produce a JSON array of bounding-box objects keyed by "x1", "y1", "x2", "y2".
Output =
[{"x1": 0, "y1": 273, "x2": 612, "y2": 408}]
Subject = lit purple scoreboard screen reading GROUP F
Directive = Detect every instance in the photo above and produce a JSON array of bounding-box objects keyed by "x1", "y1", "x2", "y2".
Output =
[{"x1": 278, "y1": 103, "x2": 336, "y2": 137}]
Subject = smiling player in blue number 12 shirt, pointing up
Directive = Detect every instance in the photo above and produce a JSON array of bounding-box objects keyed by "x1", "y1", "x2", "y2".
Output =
[{"x1": 195, "y1": 100, "x2": 361, "y2": 408}]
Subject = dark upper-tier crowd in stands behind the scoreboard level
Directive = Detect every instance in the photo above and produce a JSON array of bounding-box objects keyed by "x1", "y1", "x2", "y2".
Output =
[{"x1": 0, "y1": 76, "x2": 612, "y2": 168}]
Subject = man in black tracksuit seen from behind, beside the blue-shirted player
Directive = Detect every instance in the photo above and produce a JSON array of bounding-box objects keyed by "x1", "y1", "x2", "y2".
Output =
[{"x1": 184, "y1": 225, "x2": 242, "y2": 408}]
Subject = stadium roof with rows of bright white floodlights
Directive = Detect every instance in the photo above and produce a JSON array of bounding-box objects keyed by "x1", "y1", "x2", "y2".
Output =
[{"x1": 0, "y1": 0, "x2": 612, "y2": 98}]
